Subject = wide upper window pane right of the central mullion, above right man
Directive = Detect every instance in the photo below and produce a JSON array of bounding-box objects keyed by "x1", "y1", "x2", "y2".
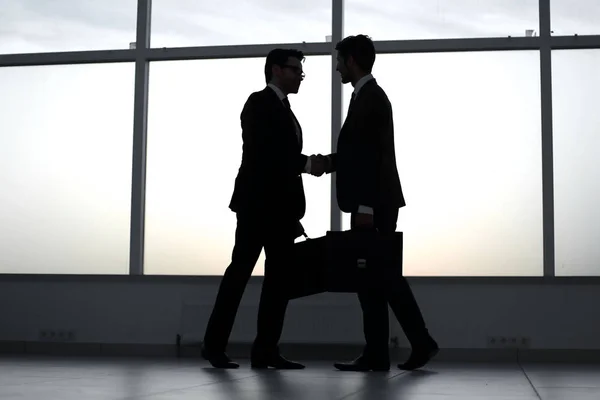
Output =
[{"x1": 344, "y1": 0, "x2": 539, "y2": 40}]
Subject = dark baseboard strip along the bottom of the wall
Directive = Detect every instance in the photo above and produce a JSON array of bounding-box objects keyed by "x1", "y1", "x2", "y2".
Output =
[{"x1": 0, "y1": 341, "x2": 600, "y2": 363}]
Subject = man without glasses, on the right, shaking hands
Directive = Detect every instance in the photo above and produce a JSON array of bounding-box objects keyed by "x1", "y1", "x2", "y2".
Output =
[{"x1": 324, "y1": 35, "x2": 438, "y2": 371}]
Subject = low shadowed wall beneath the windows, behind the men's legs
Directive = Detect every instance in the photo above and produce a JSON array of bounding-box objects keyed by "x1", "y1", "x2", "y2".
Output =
[{"x1": 0, "y1": 277, "x2": 600, "y2": 349}]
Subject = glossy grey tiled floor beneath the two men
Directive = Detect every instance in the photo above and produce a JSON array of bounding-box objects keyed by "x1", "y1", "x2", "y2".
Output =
[{"x1": 0, "y1": 356, "x2": 600, "y2": 400}]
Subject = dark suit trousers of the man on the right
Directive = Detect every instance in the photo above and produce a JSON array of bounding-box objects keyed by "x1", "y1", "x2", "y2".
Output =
[{"x1": 351, "y1": 208, "x2": 429, "y2": 359}]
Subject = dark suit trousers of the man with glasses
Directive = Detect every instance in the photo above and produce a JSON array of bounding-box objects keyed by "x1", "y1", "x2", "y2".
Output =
[{"x1": 204, "y1": 213, "x2": 296, "y2": 354}]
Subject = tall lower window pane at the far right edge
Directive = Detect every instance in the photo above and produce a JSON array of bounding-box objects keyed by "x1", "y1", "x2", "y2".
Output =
[{"x1": 552, "y1": 50, "x2": 600, "y2": 276}]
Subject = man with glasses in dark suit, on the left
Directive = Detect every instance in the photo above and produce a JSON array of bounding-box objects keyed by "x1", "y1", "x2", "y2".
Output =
[{"x1": 202, "y1": 49, "x2": 324, "y2": 369}]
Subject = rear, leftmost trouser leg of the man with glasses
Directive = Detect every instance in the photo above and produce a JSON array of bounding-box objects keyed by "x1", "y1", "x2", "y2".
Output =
[{"x1": 204, "y1": 215, "x2": 263, "y2": 352}]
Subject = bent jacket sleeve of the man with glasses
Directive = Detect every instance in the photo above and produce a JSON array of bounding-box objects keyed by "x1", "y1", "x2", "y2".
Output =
[{"x1": 241, "y1": 93, "x2": 308, "y2": 179}]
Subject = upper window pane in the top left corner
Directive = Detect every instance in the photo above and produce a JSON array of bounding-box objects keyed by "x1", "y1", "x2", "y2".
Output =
[{"x1": 0, "y1": 0, "x2": 137, "y2": 54}]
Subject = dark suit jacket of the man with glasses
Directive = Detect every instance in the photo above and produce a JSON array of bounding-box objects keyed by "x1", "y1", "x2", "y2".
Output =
[{"x1": 229, "y1": 86, "x2": 307, "y2": 222}]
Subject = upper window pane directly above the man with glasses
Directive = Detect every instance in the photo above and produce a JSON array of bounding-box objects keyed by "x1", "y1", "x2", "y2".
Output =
[{"x1": 151, "y1": 0, "x2": 331, "y2": 47}]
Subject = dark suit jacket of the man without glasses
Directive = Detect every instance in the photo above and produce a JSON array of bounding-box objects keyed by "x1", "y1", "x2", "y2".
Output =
[{"x1": 331, "y1": 79, "x2": 406, "y2": 213}]
